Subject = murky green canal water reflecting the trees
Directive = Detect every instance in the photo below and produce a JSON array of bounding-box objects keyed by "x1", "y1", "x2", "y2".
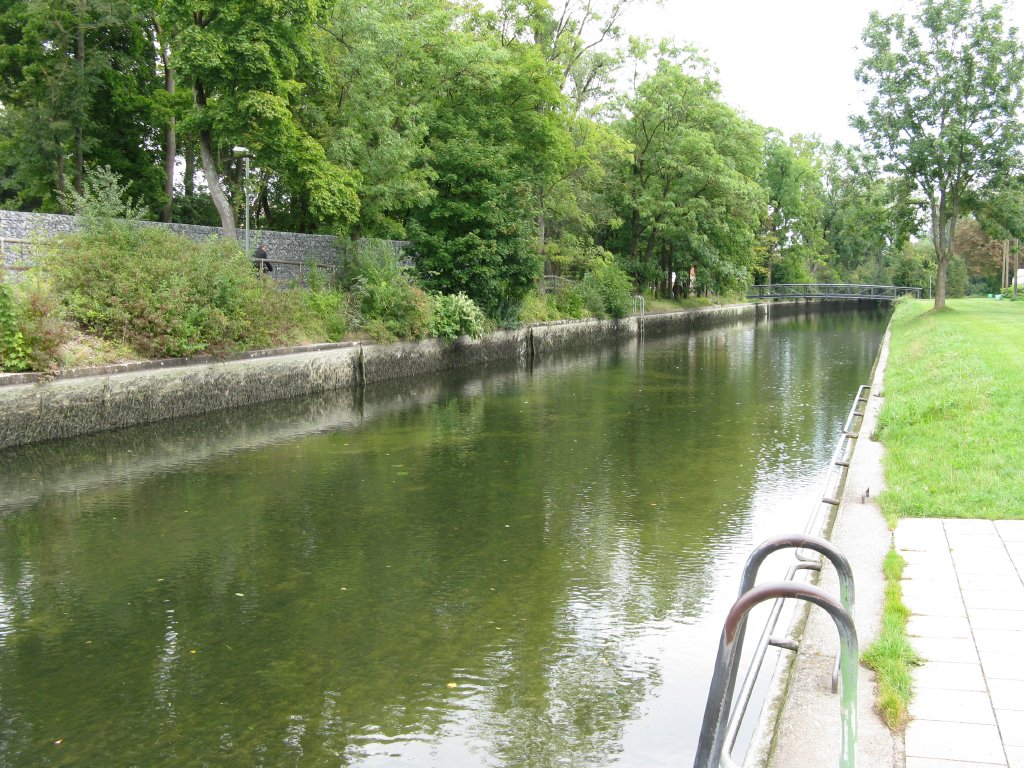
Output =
[{"x1": 0, "y1": 312, "x2": 887, "y2": 768}]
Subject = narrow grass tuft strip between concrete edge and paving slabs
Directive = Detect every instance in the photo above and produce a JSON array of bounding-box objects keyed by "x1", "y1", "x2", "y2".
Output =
[{"x1": 861, "y1": 550, "x2": 922, "y2": 730}]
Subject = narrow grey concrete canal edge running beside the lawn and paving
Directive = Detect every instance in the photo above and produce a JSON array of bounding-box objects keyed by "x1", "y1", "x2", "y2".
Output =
[{"x1": 748, "y1": 331, "x2": 904, "y2": 768}]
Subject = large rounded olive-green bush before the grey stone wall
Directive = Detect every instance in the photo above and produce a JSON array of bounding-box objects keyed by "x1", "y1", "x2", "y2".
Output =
[{"x1": 43, "y1": 222, "x2": 313, "y2": 356}]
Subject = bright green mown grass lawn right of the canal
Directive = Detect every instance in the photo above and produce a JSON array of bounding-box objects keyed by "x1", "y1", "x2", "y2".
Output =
[{"x1": 879, "y1": 299, "x2": 1024, "y2": 526}]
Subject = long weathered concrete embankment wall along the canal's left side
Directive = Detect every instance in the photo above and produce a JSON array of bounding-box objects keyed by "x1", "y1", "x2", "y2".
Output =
[{"x1": 0, "y1": 302, "x2": 868, "y2": 449}]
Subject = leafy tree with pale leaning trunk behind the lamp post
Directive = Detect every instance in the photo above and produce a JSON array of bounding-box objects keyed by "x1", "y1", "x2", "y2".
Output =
[{"x1": 160, "y1": 0, "x2": 358, "y2": 238}]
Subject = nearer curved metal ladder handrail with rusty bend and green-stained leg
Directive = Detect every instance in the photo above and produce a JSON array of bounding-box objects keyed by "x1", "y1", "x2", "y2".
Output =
[{"x1": 693, "y1": 582, "x2": 858, "y2": 768}]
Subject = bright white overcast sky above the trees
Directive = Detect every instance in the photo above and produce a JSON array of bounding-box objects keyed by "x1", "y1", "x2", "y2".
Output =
[{"x1": 623, "y1": 0, "x2": 1024, "y2": 143}]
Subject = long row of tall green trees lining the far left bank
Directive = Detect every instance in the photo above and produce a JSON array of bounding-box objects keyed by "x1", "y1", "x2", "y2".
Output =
[{"x1": 0, "y1": 0, "x2": 1003, "y2": 316}]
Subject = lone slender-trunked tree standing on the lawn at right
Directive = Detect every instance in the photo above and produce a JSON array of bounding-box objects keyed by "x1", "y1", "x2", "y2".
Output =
[{"x1": 852, "y1": 0, "x2": 1024, "y2": 309}]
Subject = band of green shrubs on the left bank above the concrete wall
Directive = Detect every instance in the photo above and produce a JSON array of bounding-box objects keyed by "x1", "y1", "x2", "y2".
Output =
[{"x1": 0, "y1": 217, "x2": 631, "y2": 372}]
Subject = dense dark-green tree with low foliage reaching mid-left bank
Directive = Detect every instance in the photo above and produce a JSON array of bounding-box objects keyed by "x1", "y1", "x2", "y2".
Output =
[{"x1": 408, "y1": 27, "x2": 569, "y2": 318}]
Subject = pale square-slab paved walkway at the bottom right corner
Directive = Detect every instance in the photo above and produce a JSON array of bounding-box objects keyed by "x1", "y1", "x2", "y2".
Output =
[{"x1": 895, "y1": 519, "x2": 1024, "y2": 768}]
